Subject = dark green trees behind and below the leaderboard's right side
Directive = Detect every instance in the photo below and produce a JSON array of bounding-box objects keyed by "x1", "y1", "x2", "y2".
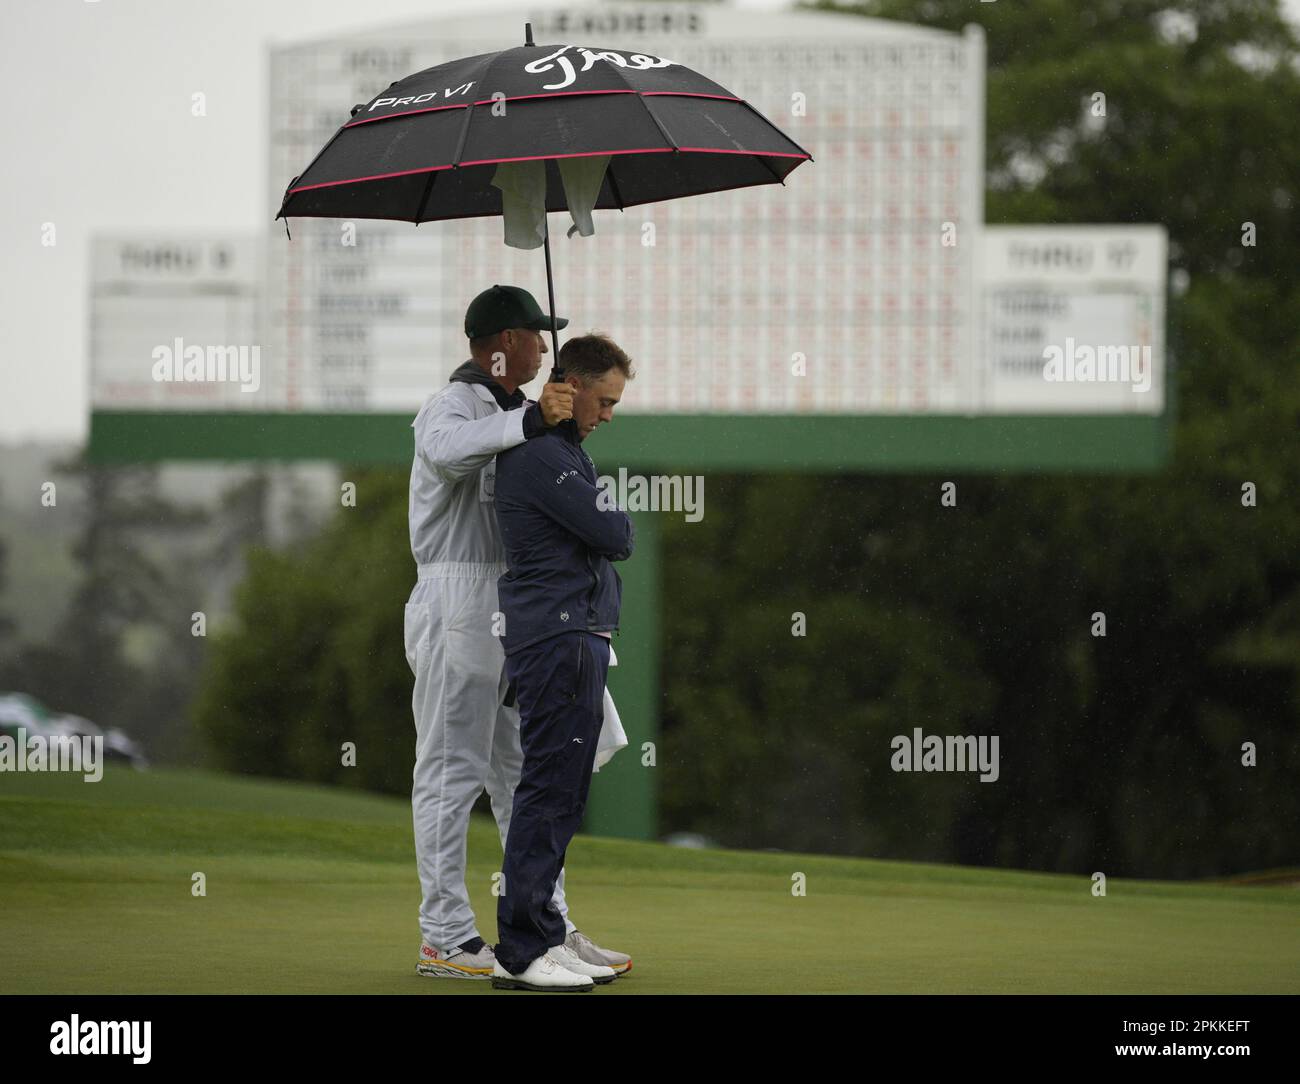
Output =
[{"x1": 660, "y1": 0, "x2": 1300, "y2": 876}]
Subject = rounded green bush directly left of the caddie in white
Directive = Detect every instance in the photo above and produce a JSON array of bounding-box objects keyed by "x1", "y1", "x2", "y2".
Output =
[{"x1": 195, "y1": 471, "x2": 415, "y2": 793}]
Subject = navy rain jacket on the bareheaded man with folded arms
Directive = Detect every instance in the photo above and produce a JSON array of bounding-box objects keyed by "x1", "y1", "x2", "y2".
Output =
[{"x1": 495, "y1": 422, "x2": 633, "y2": 655}]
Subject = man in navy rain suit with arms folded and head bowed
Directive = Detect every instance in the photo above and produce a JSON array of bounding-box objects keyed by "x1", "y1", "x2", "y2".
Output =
[{"x1": 493, "y1": 335, "x2": 633, "y2": 990}]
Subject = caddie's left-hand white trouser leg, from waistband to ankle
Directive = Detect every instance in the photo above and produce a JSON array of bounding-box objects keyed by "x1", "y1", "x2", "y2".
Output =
[{"x1": 406, "y1": 577, "x2": 502, "y2": 949}]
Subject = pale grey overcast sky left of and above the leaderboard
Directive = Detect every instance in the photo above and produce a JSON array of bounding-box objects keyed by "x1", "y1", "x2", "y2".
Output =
[{"x1": 0, "y1": 0, "x2": 1300, "y2": 443}]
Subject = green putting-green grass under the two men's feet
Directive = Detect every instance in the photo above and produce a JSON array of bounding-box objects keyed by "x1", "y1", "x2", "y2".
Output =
[{"x1": 0, "y1": 766, "x2": 1300, "y2": 998}]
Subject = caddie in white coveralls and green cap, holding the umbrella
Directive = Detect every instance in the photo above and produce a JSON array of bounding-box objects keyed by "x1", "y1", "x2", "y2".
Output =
[{"x1": 404, "y1": 286, "x2": 631, "y2": 980}]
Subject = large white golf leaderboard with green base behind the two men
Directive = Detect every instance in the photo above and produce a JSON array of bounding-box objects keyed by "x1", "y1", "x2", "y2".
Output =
[{"x1": 91, "y1": 3, "x2": 1167, "y2": 469}]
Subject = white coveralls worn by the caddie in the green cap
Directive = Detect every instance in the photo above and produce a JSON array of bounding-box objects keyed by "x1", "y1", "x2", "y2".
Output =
[{"x1": 404, "y1": 369, "x2": 627, "y2": 950}]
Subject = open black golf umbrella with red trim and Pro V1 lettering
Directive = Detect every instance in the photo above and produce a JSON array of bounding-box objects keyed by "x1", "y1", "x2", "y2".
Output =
[{"x1": 276, "y1": 27, "x2": 811, "y2": 369}]
